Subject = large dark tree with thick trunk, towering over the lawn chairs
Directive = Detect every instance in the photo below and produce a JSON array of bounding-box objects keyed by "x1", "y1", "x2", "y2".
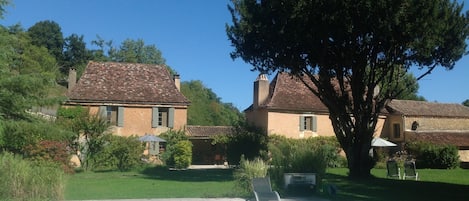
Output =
[{"x1": 227, "y1": 0, "x2": 469, "y2": 177}]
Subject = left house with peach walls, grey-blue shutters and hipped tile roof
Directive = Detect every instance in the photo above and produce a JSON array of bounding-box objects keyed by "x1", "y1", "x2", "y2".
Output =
[{"x1": 63, "y1": 61, "x2": 190, "y2": 136}]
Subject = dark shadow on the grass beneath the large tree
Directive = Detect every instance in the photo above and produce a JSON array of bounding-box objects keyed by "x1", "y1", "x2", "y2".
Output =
[{"x1": 325, "y1": 174, "x2": 469, "y2": 201}]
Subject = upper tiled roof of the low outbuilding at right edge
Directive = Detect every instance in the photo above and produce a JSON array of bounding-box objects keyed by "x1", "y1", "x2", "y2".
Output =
[{"x1": 387, "y1": 100, "x2": 469, "y2": 118}]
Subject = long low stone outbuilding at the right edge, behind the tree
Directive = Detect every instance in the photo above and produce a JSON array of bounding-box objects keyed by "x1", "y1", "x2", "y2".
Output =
[{"x1": 381, "y1": 100, "x2": 469, "y2": 163}]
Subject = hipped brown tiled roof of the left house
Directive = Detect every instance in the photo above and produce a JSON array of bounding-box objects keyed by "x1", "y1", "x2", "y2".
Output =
[{"x1": 69, "y1": 62, "x2": 190, "y2": 105}]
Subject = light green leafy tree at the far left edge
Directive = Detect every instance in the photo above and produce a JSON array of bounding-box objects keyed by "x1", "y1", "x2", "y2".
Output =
[{"x1": 0, "y1": 26, "x2": 58, "y2": 120}]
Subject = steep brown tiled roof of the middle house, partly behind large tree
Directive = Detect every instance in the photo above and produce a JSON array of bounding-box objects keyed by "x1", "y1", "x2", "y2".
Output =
[{"x1": 261, "y1": 73, "x2": 329, "y2": 112}]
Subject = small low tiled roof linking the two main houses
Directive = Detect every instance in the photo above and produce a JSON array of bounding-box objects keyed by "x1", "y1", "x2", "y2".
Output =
[{"x1": 186, "y1": 126, "x2": 234, "y2": 138}]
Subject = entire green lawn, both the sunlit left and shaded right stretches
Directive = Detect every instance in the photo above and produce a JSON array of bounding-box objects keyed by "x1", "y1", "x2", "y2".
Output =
[{"x1": 65, "y1": 168, "x2": 469, "y2": 201}]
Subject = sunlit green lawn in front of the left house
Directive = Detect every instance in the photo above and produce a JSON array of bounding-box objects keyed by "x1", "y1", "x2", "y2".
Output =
[{"x1": 65, "y1": 167, "x2": 235, "y2": 200}]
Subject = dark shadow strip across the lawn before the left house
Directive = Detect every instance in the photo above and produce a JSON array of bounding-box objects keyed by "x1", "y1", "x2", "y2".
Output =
[{"x1": 141, "y1": 166, "x2": 233, "y2": 182}]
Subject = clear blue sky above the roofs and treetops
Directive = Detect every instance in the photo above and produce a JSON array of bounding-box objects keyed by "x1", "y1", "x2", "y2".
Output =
[{"x1": 0, "y1": 0, "x2": 469, "y2": 110}]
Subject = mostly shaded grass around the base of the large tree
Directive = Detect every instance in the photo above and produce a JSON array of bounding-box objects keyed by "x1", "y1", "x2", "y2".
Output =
[{"x1": 323, "y1": 168, "x2": 469, "y2": 201}]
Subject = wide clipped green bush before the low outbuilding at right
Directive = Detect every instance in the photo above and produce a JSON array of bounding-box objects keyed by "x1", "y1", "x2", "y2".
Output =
[{"x1": 406, "y1": 142, "x2": 459, "y2": 169}]
